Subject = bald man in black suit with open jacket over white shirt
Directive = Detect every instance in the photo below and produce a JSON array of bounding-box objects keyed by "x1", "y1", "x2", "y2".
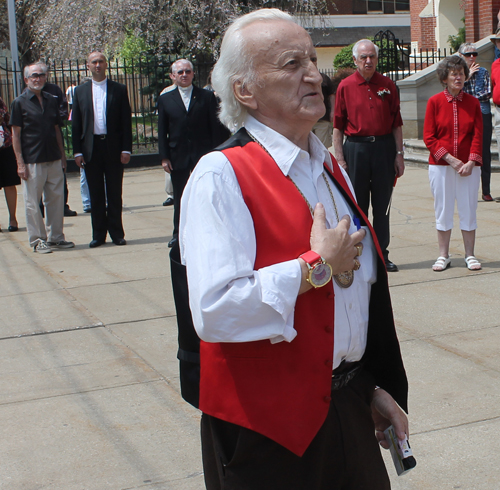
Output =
[{"x1": 72, "y1": 51, "x2": 132, "y2": 248}]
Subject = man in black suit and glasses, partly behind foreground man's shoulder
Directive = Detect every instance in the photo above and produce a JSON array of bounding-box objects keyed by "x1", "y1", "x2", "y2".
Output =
[{"x1": 158, "y1": 59, "x2": 224, "y2": 247}]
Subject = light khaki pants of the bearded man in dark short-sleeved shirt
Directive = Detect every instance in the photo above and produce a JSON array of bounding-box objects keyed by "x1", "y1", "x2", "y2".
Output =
[{"x1": 21, "y1": 160, "x2": 64, "y2": 247}]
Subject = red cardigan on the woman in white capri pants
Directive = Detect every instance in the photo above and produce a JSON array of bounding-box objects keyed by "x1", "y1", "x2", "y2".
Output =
[{"x1": 424, "y1": 89, "x2": 483, "y2": 165}]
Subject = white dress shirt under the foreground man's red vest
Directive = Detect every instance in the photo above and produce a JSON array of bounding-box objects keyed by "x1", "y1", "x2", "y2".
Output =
[{"x1": 179, "y1": 116, "x2": 376, "y2": 368}]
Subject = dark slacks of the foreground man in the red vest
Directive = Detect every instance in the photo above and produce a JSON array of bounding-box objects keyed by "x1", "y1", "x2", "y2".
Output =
[{"x1": 201, "y1": 371, "x2": 390, "y2": 490}]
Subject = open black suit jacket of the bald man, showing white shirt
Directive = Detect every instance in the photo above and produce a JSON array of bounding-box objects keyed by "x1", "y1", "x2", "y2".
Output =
[{"x1": 71, "y1": 78, "x2": 132, "y2": 162}]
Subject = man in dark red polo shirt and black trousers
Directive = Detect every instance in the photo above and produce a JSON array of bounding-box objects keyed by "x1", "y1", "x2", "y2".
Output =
[{"x1": 333, "y1": 39, "x2": 405, "y2": 272}]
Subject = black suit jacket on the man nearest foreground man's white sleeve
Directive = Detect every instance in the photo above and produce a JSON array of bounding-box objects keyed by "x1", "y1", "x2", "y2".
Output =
[{"x1": 158, "y1": 85, "x2": 224, "y2": 170}]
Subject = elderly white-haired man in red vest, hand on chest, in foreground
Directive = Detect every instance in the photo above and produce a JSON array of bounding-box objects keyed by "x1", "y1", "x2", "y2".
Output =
[{"x1": 179, "y1": 9, "x2": 408, "y2": 490}]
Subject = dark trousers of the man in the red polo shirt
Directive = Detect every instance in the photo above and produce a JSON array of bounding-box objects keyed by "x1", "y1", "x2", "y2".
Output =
[{"x1": 344, "y1": 138, "x2": 396, "y2": 260}]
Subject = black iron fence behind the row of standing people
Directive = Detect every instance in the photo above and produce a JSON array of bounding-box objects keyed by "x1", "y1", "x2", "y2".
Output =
[{"x1": 0, "y1": 46, "x2": 452, "y2": 156}]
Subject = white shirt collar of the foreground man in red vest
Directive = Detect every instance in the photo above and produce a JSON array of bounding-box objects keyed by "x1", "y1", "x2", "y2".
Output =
[{"x1": 244, "y1": 115, "x2": 333, "y2": 176}]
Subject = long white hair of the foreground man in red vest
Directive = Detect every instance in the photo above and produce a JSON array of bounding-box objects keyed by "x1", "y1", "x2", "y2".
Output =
[{"x1": 212, "y1": 9, "x2": 296, "y2": 132}]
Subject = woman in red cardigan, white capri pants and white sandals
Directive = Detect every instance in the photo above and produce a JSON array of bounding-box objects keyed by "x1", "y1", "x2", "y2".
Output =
[{"x1": 424, "y1": 55, "x2": 483, "y2": 272}]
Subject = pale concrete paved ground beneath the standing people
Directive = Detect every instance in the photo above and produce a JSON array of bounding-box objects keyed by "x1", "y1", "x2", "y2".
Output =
[{"x1": 0, "y1": 168, "x2": 500, "y2": 490}]
